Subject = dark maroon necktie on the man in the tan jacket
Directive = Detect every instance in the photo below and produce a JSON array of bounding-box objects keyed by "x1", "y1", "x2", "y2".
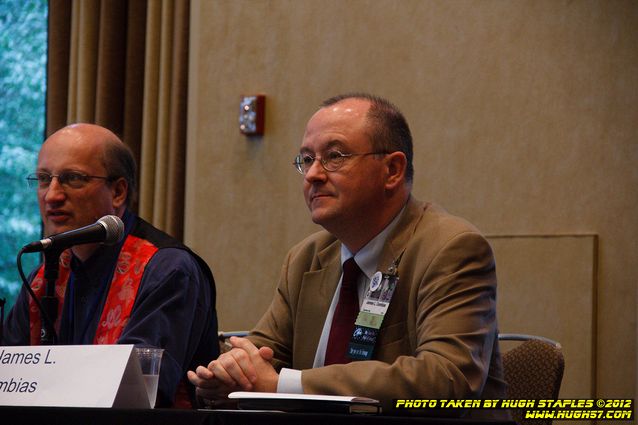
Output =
[{"x1": 324, "y1": 257, "x2": 361, "y2": 366}]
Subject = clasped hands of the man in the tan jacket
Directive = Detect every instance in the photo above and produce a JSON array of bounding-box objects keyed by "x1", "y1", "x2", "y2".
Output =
[{"x1": 187, "y1": 337, "x2": 279, "y2": 400}]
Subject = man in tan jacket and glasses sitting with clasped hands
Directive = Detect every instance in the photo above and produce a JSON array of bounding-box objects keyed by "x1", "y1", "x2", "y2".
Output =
[{"x1": 189, "y1": 94, "x2": 505, "y2": 412}]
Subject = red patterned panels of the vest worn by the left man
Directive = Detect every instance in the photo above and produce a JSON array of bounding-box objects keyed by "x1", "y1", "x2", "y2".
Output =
[{"x1": 29, "y1": 235, "x2": 158, "y2": 345}]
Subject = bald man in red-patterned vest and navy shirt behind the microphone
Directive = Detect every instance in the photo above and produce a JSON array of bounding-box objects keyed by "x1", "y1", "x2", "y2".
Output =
[{"x1": 2, "y1": 124, "x2": 219, "y2": 407}]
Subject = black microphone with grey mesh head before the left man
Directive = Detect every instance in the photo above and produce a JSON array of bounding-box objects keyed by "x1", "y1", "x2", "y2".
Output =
[{"x1": 22, "y1": 215, "x2": 124, "y2": 252}]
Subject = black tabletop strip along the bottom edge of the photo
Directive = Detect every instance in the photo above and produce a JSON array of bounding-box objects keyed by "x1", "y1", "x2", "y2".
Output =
[{"x1": 0, "y1": 406, "x2": 515, "y2": 425}]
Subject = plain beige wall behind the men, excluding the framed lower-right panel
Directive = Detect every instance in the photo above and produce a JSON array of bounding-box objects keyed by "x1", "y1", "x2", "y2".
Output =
[{"x1": 186, "y1": 0, "x2": 638, "y2": 397}]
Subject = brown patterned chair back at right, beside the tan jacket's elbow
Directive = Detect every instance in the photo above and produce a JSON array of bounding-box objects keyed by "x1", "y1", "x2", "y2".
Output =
[{"x1": 499, "y1": 334, "x2": 565, "y2": 425}]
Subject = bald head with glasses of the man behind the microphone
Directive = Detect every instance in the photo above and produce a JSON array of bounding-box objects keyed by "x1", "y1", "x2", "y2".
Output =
[{"x1": 37, "y1": 124, "x2": 135, "y2": 258}]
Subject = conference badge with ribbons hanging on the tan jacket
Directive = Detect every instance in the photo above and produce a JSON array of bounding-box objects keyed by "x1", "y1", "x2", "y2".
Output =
[{"x1": 346, "y1": 257, "x2": 400, "y2": 360}]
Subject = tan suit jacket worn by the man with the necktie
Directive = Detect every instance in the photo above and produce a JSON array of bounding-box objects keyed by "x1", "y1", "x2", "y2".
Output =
[{"x1": 249, "y1": 198, "x2": 505, "y2": 412}]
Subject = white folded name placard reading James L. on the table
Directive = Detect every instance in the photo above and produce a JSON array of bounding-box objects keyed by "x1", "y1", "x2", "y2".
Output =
[{"x1": 0, "y1": 345, "x2": 150, "y2": 408}]
